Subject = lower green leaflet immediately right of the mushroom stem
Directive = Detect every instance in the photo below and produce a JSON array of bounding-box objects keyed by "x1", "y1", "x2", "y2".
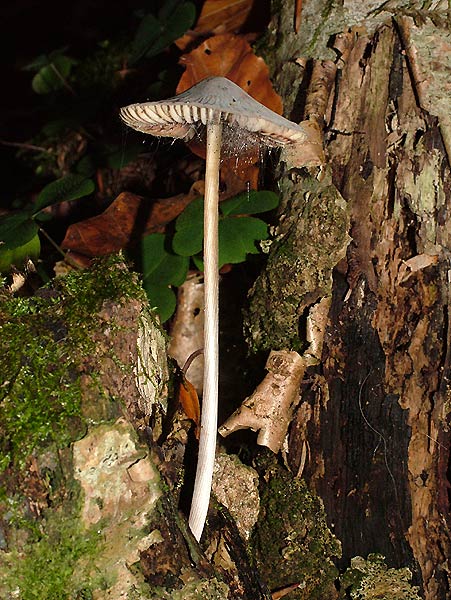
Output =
[{"x1": 219, "y1": 217, "x2": 268, "y2": 268}]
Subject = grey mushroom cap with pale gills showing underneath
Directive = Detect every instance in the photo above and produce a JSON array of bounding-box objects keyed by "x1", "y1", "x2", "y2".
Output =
[{"x1": 120, "y1": 77, "x2": 308, "y2": 146}]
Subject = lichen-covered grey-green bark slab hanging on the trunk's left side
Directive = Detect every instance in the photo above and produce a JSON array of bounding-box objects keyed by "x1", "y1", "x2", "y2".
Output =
[{"x1": 245, "y1": 169, "x2": 350, "y2": 352}]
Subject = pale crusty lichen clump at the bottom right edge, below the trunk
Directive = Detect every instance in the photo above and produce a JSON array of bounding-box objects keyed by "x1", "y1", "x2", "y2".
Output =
[{"x1": 340, "y1": 554, "x2": 421, "y2": 600}]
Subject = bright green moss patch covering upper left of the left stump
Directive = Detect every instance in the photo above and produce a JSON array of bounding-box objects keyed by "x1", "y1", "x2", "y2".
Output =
[{"x1": 0, "y1": 256, "x2": 144, "y2": 472}]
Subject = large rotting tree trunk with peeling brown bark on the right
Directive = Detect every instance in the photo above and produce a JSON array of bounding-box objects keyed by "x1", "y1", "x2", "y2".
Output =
[{"x1": 247, "y1": 1, "x2": 451, "y2": 600}]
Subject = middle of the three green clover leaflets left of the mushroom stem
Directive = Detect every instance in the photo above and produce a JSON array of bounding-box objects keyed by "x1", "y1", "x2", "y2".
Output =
[{"x1": 141, "y1": 233, "x2": 189, "y2": 286}]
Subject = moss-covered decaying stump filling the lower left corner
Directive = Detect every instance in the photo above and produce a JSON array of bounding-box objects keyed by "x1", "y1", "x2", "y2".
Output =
[{"x1": 0, "y1": 257, "x2": 240, "y2": 600}]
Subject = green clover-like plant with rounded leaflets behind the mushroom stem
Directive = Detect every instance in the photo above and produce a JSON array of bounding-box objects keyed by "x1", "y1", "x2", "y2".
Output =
[{"x1": 141, "y1": 191, "x2": 279, "y2": 322}]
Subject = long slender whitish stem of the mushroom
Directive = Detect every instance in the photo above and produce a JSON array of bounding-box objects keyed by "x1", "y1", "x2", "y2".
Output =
[{"x1": 189, "y1": 109, "x2": 222, "y2": 540}]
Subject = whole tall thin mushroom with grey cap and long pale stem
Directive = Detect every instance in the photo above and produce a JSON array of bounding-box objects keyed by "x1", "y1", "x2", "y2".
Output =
[{"x1": 120, "y1": 77, "x2": 308, "y2": 540}]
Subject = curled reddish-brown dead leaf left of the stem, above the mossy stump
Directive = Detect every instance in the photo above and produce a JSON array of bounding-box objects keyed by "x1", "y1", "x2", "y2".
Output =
[{"x1": 61, "y1": 186, "x2": 199, "y2": 257}]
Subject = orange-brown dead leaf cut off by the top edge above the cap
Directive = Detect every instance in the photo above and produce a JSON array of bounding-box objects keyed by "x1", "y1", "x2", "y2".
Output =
[{"x1": 175, "y1": 0, "x2": 254, "y2": 50}]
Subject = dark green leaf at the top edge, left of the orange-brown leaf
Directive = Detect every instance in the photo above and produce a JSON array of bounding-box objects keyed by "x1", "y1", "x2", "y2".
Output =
[{"x1": 129, "y1": 2, "x2": 196, "y2": 64}]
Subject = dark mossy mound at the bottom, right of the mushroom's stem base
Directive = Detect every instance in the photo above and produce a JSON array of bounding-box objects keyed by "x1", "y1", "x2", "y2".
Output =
[{"x1": 251, "y1": 467, "x2": 341, "y2": 600}]
